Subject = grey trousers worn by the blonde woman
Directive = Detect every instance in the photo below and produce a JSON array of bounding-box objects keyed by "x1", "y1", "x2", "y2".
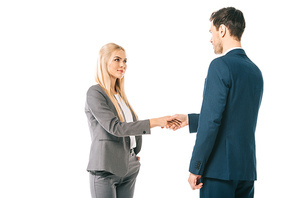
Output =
[{"x1": 89, "y1": 152, "x2": 140, "y2": 198}]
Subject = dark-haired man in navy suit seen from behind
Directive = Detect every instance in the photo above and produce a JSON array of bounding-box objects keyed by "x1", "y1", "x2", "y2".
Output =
[{"x1": 168, "y1": 7, "x2": 263, "y2": 198}]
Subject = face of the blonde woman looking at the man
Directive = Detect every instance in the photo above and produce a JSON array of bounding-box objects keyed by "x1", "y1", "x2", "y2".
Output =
[{"x1": 108, "y1": 50, "x2": 127, "y2": 80}]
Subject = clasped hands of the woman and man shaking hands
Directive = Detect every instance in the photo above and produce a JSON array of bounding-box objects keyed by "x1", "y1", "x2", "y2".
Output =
[{"x1": 150, "y1": 114, "x2": 188, "y2": 131}]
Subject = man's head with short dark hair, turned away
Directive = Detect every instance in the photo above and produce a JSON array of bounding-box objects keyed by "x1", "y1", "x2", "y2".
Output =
[{"x1": 210, "y1": 7, "x2": 246, "y2": 54}]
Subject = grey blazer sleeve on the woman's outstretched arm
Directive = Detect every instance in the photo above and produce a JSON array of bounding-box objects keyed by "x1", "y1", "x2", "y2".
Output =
[{"x1": 86, "y1": 86, "x2": 151, "y2": 137}]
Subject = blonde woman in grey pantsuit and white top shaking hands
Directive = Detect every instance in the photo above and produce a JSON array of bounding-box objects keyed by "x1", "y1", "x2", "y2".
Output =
[{"x1": 85, "y1": 43, "x2": 175, "y2": 198}]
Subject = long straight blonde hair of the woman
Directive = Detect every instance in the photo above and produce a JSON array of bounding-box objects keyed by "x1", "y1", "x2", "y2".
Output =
[{"x1": 95, "y1": 43, "x2": 138, "y2": 122}]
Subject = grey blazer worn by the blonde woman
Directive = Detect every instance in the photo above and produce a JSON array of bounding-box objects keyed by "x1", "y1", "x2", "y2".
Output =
[{"x1": 85, "y1": 85, "x2": 151, "y2": 176}]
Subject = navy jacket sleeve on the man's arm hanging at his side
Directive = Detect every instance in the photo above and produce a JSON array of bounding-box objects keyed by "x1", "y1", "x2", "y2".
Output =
[{"x1": 189, "y1": 58, "x2": 231, "y2": 175}]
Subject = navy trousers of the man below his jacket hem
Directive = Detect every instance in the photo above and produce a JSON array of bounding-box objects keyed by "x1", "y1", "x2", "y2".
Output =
[{"x1": 200, "y1": 178, "x2": 254, "y2": 198}]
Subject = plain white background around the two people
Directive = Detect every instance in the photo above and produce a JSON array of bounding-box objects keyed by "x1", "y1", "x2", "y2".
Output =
[{"x1": 0, "y1": 0, "x2": 296, "y2": 198}]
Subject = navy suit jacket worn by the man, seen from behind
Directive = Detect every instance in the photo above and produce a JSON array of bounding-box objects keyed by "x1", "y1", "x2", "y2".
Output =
[{"x1": 188, "y1": 49, "x2": 263, "y2": 180}]
